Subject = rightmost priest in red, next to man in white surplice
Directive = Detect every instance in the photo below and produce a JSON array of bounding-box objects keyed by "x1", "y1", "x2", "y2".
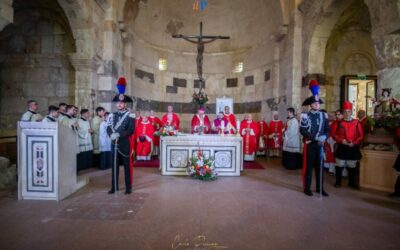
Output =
[{"x1": 268, "y1": 111, "x2": 283, "y2": 157}]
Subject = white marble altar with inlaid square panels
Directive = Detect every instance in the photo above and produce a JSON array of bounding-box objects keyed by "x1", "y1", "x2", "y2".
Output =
[{"x1": 160, "y1": 134, "x2": 243, "y2": 176}]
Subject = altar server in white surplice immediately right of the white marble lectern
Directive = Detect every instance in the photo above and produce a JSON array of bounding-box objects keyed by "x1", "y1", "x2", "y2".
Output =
[{"x1": 77, "y1": 109, "x2": 93, "y2": 171}]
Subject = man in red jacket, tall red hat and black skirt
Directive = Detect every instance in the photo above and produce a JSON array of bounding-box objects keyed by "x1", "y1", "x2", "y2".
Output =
[{"x1": 332, "y1": 101, "x2": 364, "y2": 188}]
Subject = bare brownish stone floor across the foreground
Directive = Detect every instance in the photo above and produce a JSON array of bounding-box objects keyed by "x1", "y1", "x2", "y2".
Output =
[{"x1": 0, "y1": 159, "x2": 400, "y2": 250}]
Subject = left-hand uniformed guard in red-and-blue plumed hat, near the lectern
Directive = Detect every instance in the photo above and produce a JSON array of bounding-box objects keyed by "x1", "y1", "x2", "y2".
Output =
[{"x1": 107, "y1": 78, "x2": 135, "y2": 194}]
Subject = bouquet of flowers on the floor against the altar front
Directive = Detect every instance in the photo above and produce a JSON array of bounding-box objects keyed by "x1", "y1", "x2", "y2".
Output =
[{"x1": 187, "y1": 149, "x2": 218, "y2": 181}]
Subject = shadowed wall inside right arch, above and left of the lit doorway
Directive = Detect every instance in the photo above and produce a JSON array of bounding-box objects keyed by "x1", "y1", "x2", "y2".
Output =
[{"x1": 323, "y1": 0, "x2": 377, "y2": 110}]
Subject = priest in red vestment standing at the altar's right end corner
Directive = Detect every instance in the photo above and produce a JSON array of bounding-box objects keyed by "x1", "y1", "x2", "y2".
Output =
[{"x1": 240, "y1": 114, "x2": 259, "y2": 161}]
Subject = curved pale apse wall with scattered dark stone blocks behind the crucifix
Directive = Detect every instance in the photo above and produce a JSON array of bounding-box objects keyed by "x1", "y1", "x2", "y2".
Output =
[{"x1": 125, "y1": 37, "x2": 274, "y2": 117}]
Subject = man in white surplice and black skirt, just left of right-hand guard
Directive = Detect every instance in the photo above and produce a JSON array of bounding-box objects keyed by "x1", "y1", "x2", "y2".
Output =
[{"x1": 282, "y1": 108, "x2": 301, "y2": 169}]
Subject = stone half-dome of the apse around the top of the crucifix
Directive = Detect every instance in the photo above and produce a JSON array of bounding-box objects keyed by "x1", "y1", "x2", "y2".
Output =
[{"x1": 128, "y1": 0, "x2": 282, "y2": 53}]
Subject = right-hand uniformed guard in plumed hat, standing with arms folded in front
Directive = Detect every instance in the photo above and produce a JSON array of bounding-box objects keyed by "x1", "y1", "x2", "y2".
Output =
[{"x1": 300, "y1": 80, "x2": 329, "y2": 196}]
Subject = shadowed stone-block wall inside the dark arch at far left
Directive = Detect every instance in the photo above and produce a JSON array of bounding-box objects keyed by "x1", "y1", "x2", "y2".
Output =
[{"x1": 0, "y1": 0, "x2": 76, "y2": 133}]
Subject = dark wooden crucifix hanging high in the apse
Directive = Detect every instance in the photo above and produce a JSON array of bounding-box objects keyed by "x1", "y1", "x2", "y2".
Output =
[{"x1": 172, "y1": 22, "x2": 229, "y2": 83}]
